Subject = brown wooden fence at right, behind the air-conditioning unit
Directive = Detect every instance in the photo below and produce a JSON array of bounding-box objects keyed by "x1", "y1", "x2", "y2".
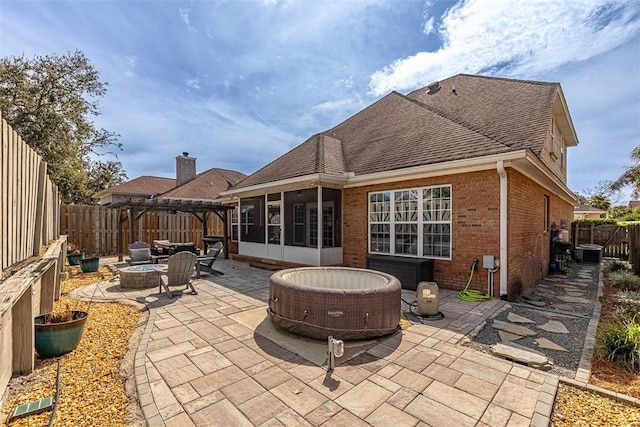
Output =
[{"x1": 571, "y1": 222, "x2": 629, "y2": 260}]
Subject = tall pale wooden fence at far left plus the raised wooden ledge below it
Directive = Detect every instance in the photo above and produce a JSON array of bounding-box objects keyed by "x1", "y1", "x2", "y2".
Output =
[{"x1": 0, "y1": 114, "x2": 66, "y2": 403}]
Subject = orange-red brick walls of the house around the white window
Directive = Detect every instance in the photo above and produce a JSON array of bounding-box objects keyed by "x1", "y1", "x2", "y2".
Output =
[{"x1": 343, "y1": 169, "x2": 573, "y2": 298}]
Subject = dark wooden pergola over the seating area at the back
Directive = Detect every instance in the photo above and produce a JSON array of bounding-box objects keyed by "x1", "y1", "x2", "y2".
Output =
[{"x1": 110, "y1": 197, "x2": 234, "y2": 261}]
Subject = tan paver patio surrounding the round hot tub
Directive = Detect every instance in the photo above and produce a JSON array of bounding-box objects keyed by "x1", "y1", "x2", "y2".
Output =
[{"x1": 72, "y1": 260, "x2": 584, "y2": 427}]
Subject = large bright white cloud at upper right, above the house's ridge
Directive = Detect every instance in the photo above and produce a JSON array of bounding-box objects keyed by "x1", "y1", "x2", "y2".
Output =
[{"x1": 369, "y1": 0, "x2": 640, "y2": 96}]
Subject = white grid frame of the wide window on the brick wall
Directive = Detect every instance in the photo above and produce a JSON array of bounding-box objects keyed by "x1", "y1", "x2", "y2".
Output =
[{"x1": 367, "y1": 184, "x2": 453, "y2": 260}]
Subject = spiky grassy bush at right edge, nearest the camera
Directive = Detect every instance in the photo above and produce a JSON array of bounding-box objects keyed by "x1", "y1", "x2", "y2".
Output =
[{"x1": 600, "y1": 321, "x2": 640, "y2": 369}]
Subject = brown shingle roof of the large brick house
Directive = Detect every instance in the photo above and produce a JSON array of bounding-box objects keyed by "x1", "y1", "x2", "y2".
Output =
[{"x1": 232, "y1": 74, "x2": 577, "y2": 191}]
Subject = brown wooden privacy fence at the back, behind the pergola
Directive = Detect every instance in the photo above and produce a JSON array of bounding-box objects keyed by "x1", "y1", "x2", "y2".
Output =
[{"x1": 60, "y1": 205, "x2": 223, "y2": 256}]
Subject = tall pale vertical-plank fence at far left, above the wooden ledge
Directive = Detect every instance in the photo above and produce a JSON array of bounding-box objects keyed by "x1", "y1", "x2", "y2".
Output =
[{"x1": 0, "y1": 113, "x2": 60, "y2": 271}]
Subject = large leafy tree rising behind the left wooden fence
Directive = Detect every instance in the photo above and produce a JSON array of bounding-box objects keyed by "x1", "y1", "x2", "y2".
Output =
[{"x1": 0, "y1": 51, "x2": 126, "y2": 203}]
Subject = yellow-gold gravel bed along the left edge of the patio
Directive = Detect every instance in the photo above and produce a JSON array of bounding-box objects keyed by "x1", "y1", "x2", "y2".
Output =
[{"x1": 2, "y1": 267, "x2": 144, "y2": 426}]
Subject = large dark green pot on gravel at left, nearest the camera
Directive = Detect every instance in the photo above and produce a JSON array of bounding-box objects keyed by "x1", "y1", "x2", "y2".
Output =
[{"x1": 34, "y1": 310, "x2": 89, "y2": 359}]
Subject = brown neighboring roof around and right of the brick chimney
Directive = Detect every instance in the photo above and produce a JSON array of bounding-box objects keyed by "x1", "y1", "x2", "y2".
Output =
[{"x1": 158, "y1": 168, "x2": 246, "y2": 200}]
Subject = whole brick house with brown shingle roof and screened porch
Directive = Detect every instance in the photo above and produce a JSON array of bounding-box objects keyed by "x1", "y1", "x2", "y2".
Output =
[{"x1": 222, "y1": 74, "x2": 578, "y2": 299}]
